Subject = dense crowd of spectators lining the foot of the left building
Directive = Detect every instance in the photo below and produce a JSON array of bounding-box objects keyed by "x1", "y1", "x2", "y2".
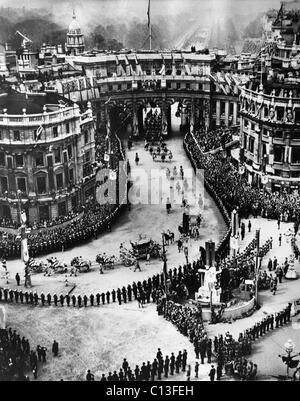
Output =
[{"x1": 0, "y1": 130, "x2": 123, "y2": 259}]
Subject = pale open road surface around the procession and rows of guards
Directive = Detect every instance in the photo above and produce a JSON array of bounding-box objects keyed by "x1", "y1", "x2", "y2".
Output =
[{"x1": 0, "y1": 137, "x2": 300, "y2": 381}]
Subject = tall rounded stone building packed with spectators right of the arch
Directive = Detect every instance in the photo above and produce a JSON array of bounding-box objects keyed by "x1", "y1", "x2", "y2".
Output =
[{"x1": 240, "y1": 5, "x2": 300, "y2": 191}]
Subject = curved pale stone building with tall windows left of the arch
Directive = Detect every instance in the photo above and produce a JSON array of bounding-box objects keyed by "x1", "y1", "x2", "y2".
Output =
[{"x1": 0, "y1": 89, "x2": 95, "y2": 223}]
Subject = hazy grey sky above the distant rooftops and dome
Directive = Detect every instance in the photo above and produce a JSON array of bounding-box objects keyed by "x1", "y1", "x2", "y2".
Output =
[{"x1": 0, "y1": 0, "x2": 288, "y2": 32}]
